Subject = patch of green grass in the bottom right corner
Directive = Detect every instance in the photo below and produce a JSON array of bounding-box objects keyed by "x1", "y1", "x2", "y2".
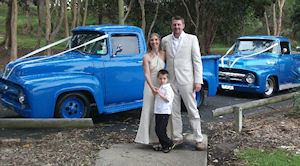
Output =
[{"x1": 238, "y1": 149, "x2": 300, "y2": 166}]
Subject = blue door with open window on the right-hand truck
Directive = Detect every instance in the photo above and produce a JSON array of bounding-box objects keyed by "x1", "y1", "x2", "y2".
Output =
[{"x1": 279, "y1": 42, "x2": 295, "y2": 85}]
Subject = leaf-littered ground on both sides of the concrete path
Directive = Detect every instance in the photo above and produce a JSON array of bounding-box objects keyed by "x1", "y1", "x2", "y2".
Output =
[{"x1": 0, "y1": 107, "x2": 300, "y2": 166}]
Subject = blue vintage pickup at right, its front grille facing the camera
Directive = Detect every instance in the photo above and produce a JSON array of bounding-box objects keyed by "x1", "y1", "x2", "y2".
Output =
[{"x1": 219, "y1": 36, "x2": 300, "y2": 97}]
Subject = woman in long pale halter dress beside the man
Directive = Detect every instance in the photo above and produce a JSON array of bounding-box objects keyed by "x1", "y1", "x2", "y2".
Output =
[{"x1": 135, "y1": 33, "x2": 166, "y2": 150}]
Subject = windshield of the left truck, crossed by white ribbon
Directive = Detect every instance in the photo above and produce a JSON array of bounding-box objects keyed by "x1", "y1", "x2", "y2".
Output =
[{"x1": 67, "y1": 33, "x2": 107, "y2": 55}]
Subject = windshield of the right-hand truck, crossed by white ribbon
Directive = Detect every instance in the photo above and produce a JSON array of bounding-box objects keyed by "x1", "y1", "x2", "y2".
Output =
[{"x1": 235, "y1": 39, "x2": 276, "y2": 53}]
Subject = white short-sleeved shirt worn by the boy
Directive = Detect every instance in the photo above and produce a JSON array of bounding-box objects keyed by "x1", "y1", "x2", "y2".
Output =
[{"x1": 154, "y1": 83, "x2": 174, "y2": 114}]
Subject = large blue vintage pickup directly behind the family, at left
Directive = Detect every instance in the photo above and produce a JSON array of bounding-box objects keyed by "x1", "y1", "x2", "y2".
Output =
[{"x1": 0, "y1": 25, "x2": 219, "y2": 118}]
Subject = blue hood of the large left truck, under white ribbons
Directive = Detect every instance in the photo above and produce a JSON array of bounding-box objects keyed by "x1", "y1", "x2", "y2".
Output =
[{"x1": 4, "y1": 52, "x2": 92, "y2": 77}]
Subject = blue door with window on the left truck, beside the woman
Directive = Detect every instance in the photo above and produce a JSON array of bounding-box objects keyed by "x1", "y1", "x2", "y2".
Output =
[{"x1": 104, "y1": 33, "x2": 145, "y2": 105}]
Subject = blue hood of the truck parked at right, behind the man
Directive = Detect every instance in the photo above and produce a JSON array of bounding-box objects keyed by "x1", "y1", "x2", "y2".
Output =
[{"x1": 219, "y1": 53, "x2": 277, "y2": 71}]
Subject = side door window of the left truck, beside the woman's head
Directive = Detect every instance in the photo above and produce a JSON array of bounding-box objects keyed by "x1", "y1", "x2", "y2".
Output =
[{"x1": 111, "y1": 34, "x2": 140, "y2": 55}]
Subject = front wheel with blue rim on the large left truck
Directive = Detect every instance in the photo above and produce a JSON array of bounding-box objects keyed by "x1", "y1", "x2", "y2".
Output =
[{"x1": 55, "y1": 92, "x2": 90, "y2": 118}]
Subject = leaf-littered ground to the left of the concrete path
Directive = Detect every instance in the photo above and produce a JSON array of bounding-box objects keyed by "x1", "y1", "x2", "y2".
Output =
[{"x1": 0, "y1": 111, "x2": 140, "y2": 166}]
